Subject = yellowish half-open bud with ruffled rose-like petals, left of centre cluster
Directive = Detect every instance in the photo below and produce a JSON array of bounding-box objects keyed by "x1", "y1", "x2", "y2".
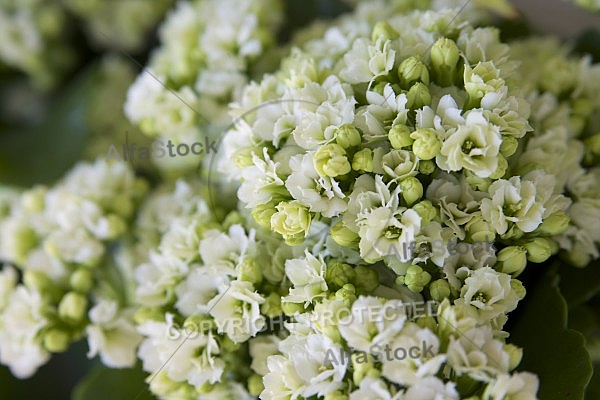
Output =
[{"x1": 271, "y1": 200, "x2": 311, "y2": 246}]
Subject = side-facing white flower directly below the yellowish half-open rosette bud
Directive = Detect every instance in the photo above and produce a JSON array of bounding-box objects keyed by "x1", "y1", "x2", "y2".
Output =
[{"x1": 282, "y1": 251, "x2": 327, "y2": 303}]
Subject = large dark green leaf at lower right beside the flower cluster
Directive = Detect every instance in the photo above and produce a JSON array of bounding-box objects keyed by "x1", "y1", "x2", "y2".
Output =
[{"x1": 511, "y1": 268, "x2": 592, "y2": 400}]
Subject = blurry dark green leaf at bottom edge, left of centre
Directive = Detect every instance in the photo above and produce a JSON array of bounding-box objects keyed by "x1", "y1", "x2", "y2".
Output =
[{"x1": 71, "y1": 366, "x2": 156, "y2": 400}]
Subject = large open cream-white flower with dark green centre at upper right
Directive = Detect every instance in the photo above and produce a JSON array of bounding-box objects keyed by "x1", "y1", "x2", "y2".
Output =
[{"x1": 436, "y1": 110, "x2": 502, "y2": 178}]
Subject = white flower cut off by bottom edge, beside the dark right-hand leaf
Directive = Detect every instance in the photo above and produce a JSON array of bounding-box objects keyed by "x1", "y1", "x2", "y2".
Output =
[{"x1": 481, "y1": 372, "x2": 540, "y2": 400}]
